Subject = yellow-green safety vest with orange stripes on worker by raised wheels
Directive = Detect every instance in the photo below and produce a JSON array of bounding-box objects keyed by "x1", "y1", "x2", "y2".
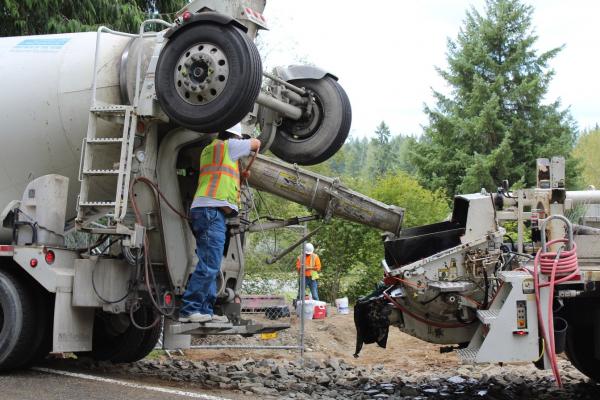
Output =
[{"x1": 194, "y1": 139, "x2": 240, "y2": 204}]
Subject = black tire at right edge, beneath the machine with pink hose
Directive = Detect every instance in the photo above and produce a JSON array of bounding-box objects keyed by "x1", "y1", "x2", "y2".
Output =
[{"x1": 565, "y1": 321, "x2": 600, "y2": 381}]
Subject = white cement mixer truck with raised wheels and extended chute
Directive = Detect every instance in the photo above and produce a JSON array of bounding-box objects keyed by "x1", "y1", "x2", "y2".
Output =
[{"x1": 0, "y1": 0, "x2": 403, "y2": 370}]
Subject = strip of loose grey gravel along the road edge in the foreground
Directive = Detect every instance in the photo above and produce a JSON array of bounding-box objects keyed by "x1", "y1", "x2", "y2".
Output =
[{"x1": 83, "y1": 358, "x2": 600, "y2": 400}]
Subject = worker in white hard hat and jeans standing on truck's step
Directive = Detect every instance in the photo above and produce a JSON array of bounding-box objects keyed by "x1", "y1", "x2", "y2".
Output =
[{"x1": 179, "y1": 124, "x2": 260, "y2": 322}]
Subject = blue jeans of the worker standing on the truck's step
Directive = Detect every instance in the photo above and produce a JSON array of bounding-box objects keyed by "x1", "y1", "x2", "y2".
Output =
[{"x1": 179, "y1": 207, "x2": 227, "y2": 316}]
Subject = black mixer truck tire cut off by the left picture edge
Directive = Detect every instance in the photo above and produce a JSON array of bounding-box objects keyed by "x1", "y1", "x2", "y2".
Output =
[{"x1": 0, "y1": 270, "x2": 39, "y2": 371}]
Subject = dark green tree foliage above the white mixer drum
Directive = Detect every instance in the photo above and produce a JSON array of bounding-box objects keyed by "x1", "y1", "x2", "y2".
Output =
[{"x1": 0, "y1": 0, "x2": 187, "y2": 36}]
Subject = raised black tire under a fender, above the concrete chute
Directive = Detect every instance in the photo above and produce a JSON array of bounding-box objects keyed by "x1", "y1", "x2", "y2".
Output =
[{"x1": 271, "y1": 76, "x2": 352, "y2": 165}]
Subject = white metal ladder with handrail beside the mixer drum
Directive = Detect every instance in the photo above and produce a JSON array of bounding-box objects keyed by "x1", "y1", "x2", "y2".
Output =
[{"x1": 76, "y1": 19, "x2": 171, "y2": 235}]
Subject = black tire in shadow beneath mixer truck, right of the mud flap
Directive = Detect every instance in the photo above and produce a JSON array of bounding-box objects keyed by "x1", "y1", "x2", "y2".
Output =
[{"x1": 82, "y1": 307, "x2": 161, "y2": 363}]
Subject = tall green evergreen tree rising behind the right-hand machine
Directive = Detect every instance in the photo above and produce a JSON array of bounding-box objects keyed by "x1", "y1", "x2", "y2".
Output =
[{"x1": 410, "y1": 0, "x2": 577, "y2": 194}]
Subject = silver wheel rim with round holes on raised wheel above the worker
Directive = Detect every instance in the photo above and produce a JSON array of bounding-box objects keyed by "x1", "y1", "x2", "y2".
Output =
[{"x1": 174, "y1": 43, "x2": 229, "y2": 105}]
